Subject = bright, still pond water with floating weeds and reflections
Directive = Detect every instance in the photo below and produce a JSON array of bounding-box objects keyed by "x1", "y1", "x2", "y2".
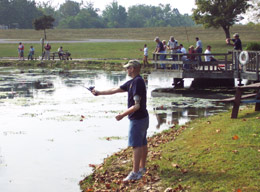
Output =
[{"x1": 0, "y1": 67, "x2": 231, "y2": 192}]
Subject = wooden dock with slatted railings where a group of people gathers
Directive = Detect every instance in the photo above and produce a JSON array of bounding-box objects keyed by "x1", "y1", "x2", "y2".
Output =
[{"x1": 151, "y1": 51, "x2": 260, "y2": 87}]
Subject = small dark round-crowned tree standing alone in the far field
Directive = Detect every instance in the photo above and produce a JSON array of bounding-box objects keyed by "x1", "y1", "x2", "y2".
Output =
[{"x1": 33, "y1": 15, "x2": 55, "y2": 39}]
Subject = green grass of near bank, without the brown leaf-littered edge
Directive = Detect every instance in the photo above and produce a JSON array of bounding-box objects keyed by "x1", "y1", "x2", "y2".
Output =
[{"x1": 156, "y1": 106, "x2": 260, "y2": 191}]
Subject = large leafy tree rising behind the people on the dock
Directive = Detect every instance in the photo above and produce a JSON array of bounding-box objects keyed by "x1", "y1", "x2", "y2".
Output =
[{"x1": 193, "y1": 0, "x2": 250, "y2": 38}]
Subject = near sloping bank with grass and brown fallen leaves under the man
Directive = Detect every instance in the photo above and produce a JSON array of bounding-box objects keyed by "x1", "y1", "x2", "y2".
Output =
[{"x1": 80, "y1": 107, "x2": 260, "y2": 192}]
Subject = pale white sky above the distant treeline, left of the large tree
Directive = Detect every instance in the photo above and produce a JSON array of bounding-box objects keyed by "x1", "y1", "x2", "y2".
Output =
[{"x1": 35, "y1": 0, "x2": 195, "y2": 14}]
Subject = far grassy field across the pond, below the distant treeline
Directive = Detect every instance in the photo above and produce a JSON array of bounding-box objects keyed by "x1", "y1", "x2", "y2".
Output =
[{"x1": 0, "y1": 26, "x2": 260, "y2": 59}]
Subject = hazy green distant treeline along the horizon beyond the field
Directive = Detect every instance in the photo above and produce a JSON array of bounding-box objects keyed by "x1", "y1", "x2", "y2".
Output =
[{"x1": 0, "y1": 0, "x2": 195, "y2": 29}]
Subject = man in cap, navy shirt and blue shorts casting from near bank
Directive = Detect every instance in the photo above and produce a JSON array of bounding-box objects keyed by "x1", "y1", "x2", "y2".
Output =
[{"x1": 92, "y1": 60, "x2": 149, "y2": 181}]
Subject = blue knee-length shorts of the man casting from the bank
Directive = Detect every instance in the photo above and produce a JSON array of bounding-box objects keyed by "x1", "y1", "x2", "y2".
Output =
[{"x1": 128, "y1": 116, "x2": 149, "y2": 147}]
